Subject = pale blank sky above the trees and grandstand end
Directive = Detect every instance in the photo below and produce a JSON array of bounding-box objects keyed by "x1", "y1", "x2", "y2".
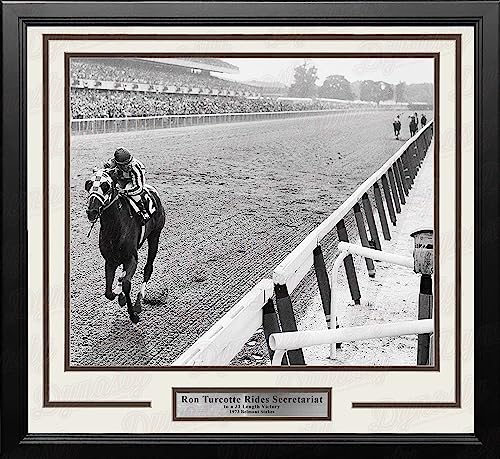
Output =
[{"x1": 221, "y1": 57, "x2": 434, "y2": 85}]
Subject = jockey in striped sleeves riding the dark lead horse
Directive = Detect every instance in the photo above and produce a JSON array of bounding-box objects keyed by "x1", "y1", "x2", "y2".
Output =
[{"x1": 104, "y1": 148, "x2": 148, "y2": 221}]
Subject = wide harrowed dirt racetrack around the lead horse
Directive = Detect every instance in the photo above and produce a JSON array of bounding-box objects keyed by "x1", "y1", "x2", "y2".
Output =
[{"x1": 70, "y1": 111, "x2": 431, "y2": 366}]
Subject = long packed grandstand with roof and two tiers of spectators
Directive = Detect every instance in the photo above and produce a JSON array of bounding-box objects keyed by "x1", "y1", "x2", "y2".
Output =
[{"x1": 70, "y1": 57, "x2": 352, "y2": 120}]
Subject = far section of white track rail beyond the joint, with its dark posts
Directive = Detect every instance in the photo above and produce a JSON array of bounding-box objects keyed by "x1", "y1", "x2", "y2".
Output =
[{"x1": 271, "y1": 122, "x2": 434, "y2": 365}]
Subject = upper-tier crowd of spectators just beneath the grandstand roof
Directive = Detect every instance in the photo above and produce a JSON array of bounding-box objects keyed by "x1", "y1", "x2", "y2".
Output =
[{"x1": 71, "y1": 58, "x2": 256, "y2": 93}]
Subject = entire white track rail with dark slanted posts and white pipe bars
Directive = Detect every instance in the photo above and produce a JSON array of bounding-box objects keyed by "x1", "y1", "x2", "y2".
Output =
[{"x1": 173, "y1": 121, "x2": 434, "y2": 366}]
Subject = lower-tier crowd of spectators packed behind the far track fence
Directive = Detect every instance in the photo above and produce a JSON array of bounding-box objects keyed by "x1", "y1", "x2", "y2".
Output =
[{"x1": 71, "y1": 88, "x2": 344, "y2": 119}]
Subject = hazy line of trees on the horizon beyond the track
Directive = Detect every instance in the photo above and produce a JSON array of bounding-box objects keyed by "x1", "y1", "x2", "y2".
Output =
[{"x1": 288, "y1": 63, "x2": 433, "y2": 104}]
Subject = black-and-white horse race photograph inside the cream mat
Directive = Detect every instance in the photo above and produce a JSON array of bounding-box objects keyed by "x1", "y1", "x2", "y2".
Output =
[{"x1": 66, "y1": 55, "x2": 438, "y2": 369}]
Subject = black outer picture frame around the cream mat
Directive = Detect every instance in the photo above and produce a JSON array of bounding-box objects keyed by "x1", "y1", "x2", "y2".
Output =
[{"x1": 1, "y1": 1, "x2": 500, "y2": 457}]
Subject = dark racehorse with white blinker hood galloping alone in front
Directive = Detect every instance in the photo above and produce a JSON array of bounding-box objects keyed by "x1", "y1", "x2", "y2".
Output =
[{"x1": 85, "y1": 169, "x2": 165, "y2": 324}]
